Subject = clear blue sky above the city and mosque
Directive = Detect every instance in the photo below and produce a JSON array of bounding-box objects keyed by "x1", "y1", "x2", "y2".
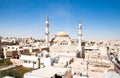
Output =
[{"x1": 0, "y1": 0, "x2": 120, "y2": 40}]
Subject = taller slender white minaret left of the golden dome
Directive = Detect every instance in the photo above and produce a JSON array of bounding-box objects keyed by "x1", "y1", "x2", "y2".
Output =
[{"x1": 45, "y1": 16, "x2": 49, "y2": 47}]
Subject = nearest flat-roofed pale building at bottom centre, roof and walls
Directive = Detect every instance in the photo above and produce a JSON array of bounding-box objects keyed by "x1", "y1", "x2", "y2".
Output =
[{"x1": 24, "y1": 66, "x2": 72, "y2": 78}]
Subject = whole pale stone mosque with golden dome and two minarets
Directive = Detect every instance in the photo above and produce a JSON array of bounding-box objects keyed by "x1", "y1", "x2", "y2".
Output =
[{"x1": 45, "y1": 17, "x2": 82, "y2": 52}]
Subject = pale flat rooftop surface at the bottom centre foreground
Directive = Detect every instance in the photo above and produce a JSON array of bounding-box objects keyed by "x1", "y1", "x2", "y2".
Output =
[{"x1": 25, "y1": 66, "x2": 70, "y2": 77}]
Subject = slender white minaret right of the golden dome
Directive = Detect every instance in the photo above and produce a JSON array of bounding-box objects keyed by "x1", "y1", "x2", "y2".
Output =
[{"x1": 78, "y1": 22, "x2": 82, "y2": 51}]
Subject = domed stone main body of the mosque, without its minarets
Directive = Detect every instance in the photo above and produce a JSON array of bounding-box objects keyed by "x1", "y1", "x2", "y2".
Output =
[{"x1": 50, "y1": 32, "x2": 78, "y2": 52}]
